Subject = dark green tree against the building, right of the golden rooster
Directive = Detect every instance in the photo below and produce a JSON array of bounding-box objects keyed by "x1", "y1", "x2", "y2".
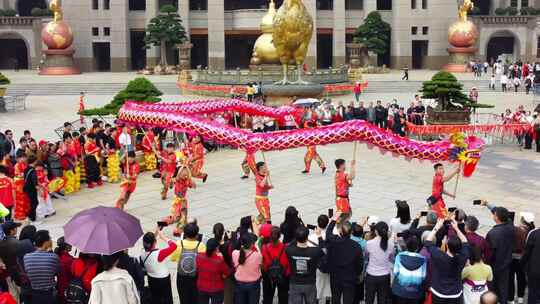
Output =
[{"x1": 354, "y1": 11, "x2": 391, "y2": 55}]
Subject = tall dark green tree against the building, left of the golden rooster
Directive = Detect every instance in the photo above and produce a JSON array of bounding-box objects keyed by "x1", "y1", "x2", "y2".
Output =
[{"x1": 144, "y1": 5, "x2": 187, "y2": 66}]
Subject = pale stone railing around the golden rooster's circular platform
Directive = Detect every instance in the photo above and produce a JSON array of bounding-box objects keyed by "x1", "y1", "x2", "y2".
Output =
[{"x1": 192, "y1": 67, "x2": 349, "y2": 85}]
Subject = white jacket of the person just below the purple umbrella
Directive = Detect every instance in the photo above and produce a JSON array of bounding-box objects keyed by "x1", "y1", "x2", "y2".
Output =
[{"x1": 88, "y1": 267, "x2": 141, "y2": 304}]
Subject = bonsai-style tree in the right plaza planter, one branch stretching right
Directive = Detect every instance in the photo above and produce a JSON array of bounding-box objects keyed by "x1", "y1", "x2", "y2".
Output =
[{"x1": 420, "y1": 71, "x2": 493, "y2": 111}]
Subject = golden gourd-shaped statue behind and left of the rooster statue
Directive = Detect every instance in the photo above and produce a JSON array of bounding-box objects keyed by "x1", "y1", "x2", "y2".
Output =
[{"x1": 251, "y1": 0, "x2": 279, "y2": 65}]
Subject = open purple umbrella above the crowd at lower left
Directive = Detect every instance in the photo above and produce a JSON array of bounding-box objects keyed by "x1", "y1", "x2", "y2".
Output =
[{"x1": 64, "y1": 206, "x2": 143, "y2": 255}]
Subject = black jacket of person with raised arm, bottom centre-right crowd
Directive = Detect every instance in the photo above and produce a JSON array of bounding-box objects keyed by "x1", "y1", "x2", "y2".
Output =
[{"x1": 326, "y1": 221, "x2": 364, "y2": 286}]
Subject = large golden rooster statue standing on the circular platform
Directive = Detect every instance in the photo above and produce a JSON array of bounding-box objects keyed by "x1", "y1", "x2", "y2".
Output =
[{"x1": 272, "y1": 0, "x2": 313, "y2": 84}]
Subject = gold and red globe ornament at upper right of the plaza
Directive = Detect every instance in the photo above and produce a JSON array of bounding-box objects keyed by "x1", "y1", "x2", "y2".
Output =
[{"x1": 448, "y1": 0, "x2": 478, "y2": 48}]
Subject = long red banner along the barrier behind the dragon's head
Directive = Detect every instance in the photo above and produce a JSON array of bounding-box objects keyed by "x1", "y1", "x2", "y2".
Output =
[{"x1": 407, "y1": 122, "x2": 532, "y2": 135}]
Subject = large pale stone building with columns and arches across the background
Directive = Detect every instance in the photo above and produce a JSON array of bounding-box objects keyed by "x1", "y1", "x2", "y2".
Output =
[{"x1": 0, "y1": 0, "x2": 540, "y2": 72}]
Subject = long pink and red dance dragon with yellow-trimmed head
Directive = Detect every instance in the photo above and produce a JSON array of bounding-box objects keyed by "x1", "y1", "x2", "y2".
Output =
[{"x1": 118, "y1": 99, "x2": 485, "y2": 177}]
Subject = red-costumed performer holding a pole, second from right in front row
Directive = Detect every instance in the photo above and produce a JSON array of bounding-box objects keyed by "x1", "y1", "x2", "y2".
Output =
[{"x1": 335, "y1": 158, "x2": 356, "y2": 216}]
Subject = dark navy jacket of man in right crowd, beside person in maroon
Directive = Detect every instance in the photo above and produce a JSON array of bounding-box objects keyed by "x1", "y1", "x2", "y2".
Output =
[{"x1": 486, "y1": 222, "x2": 516, "y2": 273}]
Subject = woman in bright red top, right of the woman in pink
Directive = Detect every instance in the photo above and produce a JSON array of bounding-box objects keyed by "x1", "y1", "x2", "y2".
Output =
[{"x1": 261, "y1": 227, "x2": 291, "y2": 304}]
